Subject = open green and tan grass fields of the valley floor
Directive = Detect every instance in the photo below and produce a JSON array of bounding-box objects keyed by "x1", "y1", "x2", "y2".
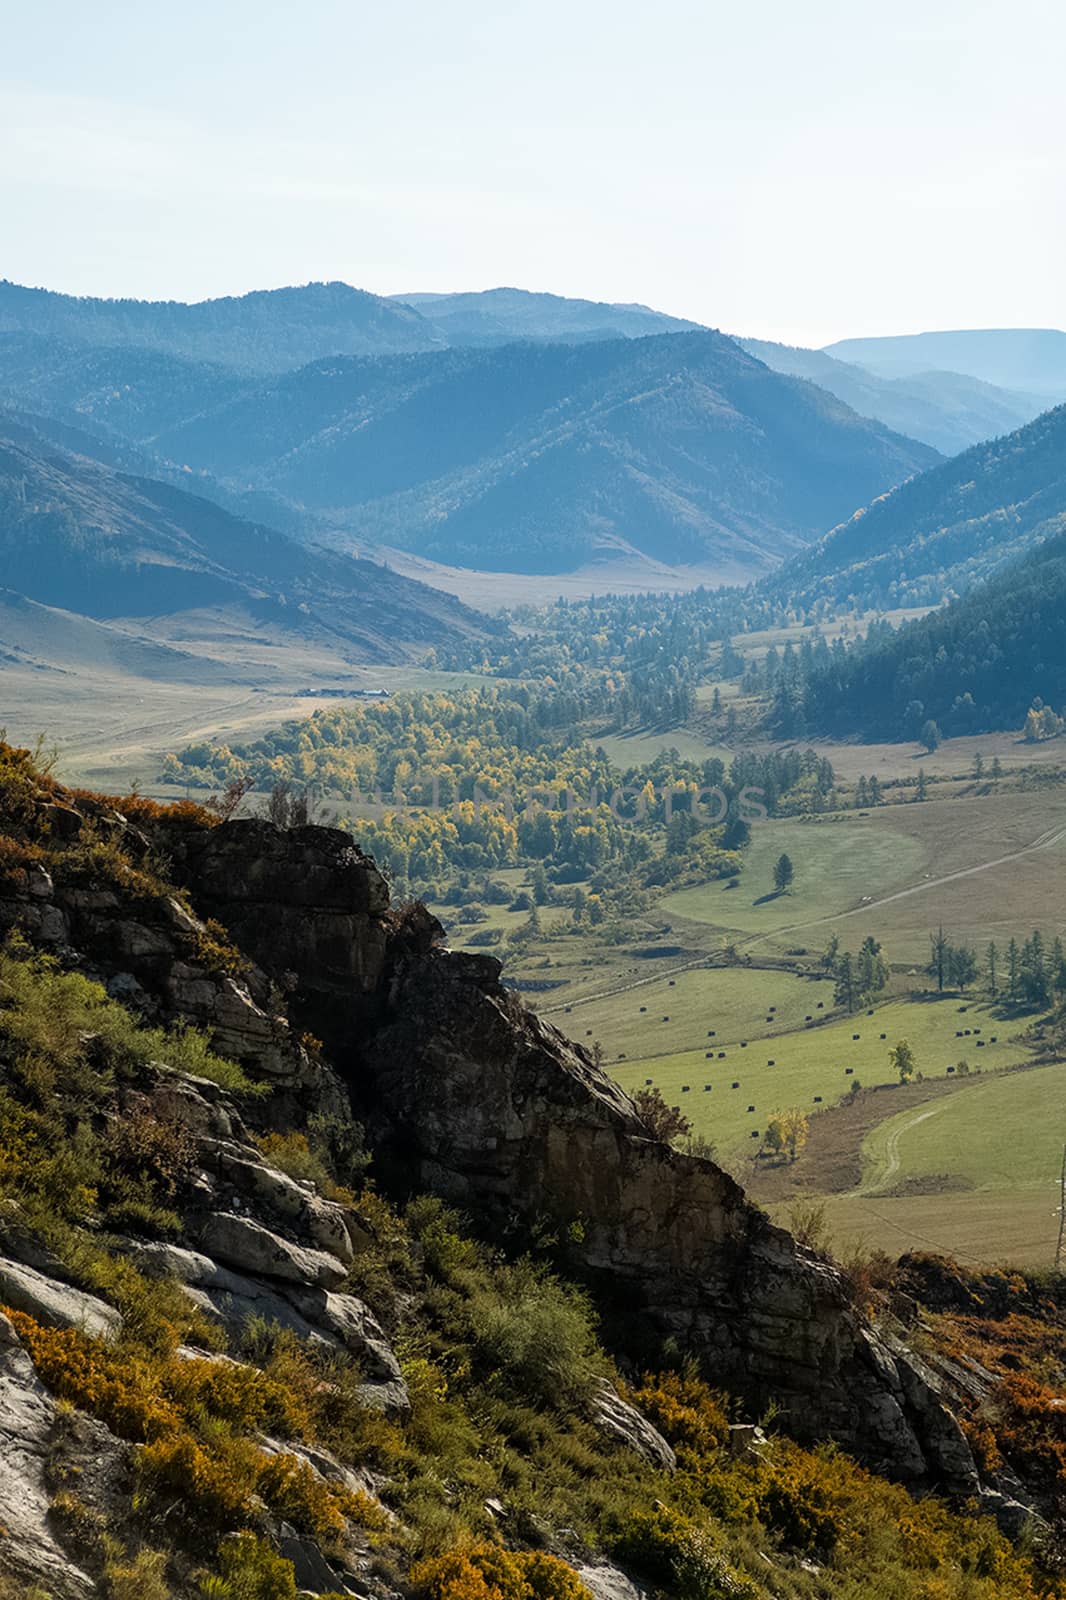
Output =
[{"x1": 10, "y1": 642, "x2": 1066, "y2": 1266}]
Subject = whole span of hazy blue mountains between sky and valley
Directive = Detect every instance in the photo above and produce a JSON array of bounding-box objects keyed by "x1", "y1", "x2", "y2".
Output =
[{"x1": 0, "y1": 283, "x2": 1066, "y2": 732}]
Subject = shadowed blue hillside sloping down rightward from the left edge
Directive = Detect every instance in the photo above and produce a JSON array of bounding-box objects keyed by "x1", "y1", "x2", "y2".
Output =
[{"x1": 0, "y1": 414, "x2": 488, "y2": 661}]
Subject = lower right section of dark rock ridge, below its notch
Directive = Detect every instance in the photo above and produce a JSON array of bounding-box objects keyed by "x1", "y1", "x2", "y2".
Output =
[{"x1": 349, "y1": 950, "x2": 978, "y2": 1494}]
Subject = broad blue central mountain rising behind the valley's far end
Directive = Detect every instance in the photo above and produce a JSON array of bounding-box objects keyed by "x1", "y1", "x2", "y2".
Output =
[{"x1": 0, "y1": 318, "x2": 938, "y2": 581}]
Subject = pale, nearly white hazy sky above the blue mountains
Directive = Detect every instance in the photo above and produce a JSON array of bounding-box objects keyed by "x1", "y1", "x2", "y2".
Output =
[{"x1": 0, "y1": 0, "x2": 1066, "y2": 344}]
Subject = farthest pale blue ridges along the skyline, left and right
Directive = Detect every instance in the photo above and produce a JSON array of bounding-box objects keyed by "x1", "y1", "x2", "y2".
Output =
[{"x1": 0, "y1": 283, "x2": 1066, "y2": 467}]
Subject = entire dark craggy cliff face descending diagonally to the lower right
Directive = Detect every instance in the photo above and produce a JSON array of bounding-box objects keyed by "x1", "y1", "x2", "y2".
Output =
[{"x1": 164, "y1": 822, "x2": 978, "y2": 1493}]
